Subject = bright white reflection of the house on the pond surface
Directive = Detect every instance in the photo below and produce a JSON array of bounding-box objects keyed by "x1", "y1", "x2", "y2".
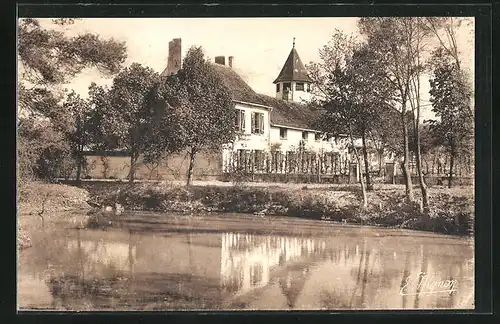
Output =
[{"x1": 221, "y1": 233, "x2": 326, "y2": 295}]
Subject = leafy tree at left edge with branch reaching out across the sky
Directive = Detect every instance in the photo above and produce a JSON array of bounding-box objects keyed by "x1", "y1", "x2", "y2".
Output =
[{"x1": 17, "y1": 18, "x2": 126, "y2": 186}]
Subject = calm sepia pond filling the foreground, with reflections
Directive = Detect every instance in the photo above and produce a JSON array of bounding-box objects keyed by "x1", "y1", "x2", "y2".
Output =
[{"x1": 18, "y1": 213, "x2": 474, "y2": 310}]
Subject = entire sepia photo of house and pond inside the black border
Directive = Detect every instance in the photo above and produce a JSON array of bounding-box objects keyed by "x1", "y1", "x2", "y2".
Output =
[{"x1": 16, "y1": 17, "x2": 475, "y2": 311}]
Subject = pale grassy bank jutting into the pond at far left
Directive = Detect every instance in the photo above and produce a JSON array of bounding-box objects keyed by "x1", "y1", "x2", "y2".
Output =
[{"x1": 17, "y1": 182, "x2": 91, "y2": 249}]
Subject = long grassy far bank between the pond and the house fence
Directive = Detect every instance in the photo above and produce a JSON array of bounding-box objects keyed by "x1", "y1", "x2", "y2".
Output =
[{"x1": 83, "y1": 182, "x2": 474, "y2": 234}]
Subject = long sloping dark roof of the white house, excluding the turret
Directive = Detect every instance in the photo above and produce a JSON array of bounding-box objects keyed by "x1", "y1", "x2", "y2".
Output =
[{"x1": 213, "y1": 64, "x2": 318, "y2": 129}]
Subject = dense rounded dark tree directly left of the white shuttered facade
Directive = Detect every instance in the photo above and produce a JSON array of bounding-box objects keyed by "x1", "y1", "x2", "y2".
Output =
[{"x1": 163, "y1": 47, "x2": 236, "y2": 185}]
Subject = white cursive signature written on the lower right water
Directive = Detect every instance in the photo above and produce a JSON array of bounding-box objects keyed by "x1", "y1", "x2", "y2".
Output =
[{"x1": 399, "y1": 272, "x2": 458, "y2": 296}]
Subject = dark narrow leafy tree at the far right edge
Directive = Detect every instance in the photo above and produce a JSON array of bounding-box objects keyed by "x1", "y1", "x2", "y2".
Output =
[{"x1": 429, "y1": 48, "x2": 474, "y2": 188}]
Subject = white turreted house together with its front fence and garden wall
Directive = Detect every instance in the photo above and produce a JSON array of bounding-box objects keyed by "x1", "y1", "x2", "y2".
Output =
[{"x1": 76, "y1": 38, "x2": 398, "y2": 182}]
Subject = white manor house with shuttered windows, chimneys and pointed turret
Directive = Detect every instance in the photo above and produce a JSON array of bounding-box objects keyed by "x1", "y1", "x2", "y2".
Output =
[{"x1": 162, "y1": 38, "x2": 349, "y2": 180}]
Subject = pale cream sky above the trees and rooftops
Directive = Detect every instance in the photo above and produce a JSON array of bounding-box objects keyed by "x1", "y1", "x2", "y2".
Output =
[{"x1": 37, "y1": 17, "x2": 474, "y2": 118}]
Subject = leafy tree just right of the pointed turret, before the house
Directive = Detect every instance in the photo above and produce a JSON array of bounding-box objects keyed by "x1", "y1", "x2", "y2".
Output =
[{"x1": 309, "y1": 31, "x2": 393, "y2": 197}]
